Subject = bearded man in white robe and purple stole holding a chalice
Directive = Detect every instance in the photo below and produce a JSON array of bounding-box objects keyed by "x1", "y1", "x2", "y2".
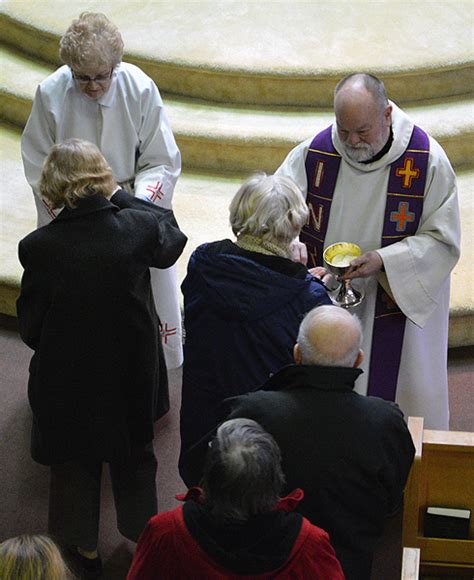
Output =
[{"x1": 276, "y1": 74, "x2": 460, "y2": 429}]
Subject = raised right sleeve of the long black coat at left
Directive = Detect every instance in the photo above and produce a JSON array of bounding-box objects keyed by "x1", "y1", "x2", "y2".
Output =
[{"x1": 110, "y1": 189, "x2": 188, "y2": 268}]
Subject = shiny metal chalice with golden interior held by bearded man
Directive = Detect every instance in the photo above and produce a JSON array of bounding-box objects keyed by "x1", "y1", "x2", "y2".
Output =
[{"x1": 323, "y1": 242, "x2": 364, "y2": 308}]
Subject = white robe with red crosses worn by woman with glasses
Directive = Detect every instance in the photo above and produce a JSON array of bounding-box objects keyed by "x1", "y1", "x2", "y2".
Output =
[{"x1": 21, "y1": 63, "x2": 183, "y2": 368}]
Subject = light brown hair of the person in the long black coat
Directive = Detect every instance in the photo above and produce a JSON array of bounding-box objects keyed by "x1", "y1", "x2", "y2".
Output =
[{"x1": 39, "y1": 139, "x2": 116, "y2": 209}]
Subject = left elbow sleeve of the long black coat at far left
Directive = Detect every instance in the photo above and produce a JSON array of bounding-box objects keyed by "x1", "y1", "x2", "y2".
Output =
[{"x1": 16, "y1": 241, "x2": 51, "y2": 350}]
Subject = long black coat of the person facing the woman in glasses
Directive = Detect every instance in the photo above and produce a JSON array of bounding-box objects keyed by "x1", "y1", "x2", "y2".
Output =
[{"x1": 17, "y1": 191, "x2": 186, "y2": 465}]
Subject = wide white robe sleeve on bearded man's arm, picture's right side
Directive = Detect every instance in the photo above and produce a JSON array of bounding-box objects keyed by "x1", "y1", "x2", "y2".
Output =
[{"x1": 377, "y1": 139, "x2": 461, "y2": 328}]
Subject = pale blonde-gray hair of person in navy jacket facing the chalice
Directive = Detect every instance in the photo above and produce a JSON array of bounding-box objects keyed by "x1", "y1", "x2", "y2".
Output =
[{"x1": 229, "y1": 173, "x2": 308, "y2": 246}]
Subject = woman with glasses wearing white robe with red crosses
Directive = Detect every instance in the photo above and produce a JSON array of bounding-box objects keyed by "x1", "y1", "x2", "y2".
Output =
[{"x1": 21, "y1": 13, "x2": 183, "y2": 368}]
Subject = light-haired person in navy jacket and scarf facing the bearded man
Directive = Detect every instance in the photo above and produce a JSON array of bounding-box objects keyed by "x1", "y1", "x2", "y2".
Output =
[{"x1": 180, "y1": 174, "x2": 331, "y2": 476}]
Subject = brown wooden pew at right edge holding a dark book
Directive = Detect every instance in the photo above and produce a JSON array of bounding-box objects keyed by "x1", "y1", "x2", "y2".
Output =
[{"x1": 403, "y1": 417, "x2": 474, "y2": 577}]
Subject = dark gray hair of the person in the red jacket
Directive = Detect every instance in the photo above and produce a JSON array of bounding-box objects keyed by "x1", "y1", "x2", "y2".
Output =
[{"x1": 201, "y1": 419, "x2": 285, "y2": 522}]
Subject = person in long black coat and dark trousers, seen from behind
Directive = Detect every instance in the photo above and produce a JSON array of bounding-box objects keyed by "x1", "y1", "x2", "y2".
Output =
[{"x1": 17, "y1": 139, "x2": 186, "y2": 573}]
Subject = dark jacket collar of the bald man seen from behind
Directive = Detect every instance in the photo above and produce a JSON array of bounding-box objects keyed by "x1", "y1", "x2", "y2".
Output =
[{"x1": 261, "y1": 364, "x2": 363, "y2": 391}]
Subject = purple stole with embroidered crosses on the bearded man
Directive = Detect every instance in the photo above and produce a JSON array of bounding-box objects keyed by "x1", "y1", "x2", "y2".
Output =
[{"x1": 300, "y1": 126, "x2": 429, "y2": 401}]
